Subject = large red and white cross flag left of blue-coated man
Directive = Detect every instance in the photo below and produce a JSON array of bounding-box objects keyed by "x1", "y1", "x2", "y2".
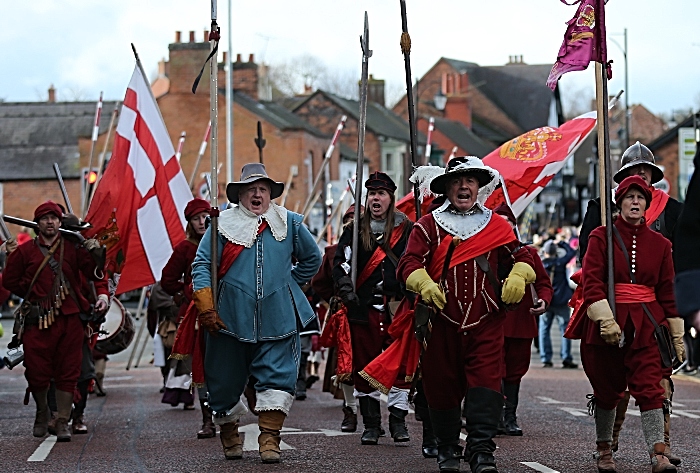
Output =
[{"x1": 85, "y1": 61, "x2": 192, "y2": 294}]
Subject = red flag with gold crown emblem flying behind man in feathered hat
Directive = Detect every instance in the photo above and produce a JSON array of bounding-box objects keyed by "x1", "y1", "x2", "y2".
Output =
[{"x1": 484, "y1": 112, "x2": 596, "y2": 217}]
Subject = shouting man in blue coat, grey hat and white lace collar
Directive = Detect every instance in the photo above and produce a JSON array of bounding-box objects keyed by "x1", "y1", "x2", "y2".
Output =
[{"x1": 192, "y1": 163, "x2": 321, "y2": 463}]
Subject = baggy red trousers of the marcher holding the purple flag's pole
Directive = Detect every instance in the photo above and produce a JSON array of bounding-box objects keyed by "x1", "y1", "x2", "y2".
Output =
[{"x1": 581, "y1": 342, "x2": 664, "y2": 411}]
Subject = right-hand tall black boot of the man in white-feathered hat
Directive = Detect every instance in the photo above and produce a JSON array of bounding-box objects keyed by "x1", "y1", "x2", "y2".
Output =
[{"x1": 465, "y1": 388, "x2": 503, "y2": 473}]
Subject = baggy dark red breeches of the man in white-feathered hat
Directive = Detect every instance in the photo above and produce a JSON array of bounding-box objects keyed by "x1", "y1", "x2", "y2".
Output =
[{"x1": 422, "y1": 315, "x2": 504, "y2": 410}]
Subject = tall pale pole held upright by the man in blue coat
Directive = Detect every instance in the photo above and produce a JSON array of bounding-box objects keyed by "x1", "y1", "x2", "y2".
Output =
[{"x1": 209, "y1": 0, "x2": 221, "y2": 309}]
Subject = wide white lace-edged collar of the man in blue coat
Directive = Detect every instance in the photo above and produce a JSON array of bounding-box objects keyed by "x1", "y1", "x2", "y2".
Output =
[{"x1": 219, "y1": 202, "x2": 287, "y2": 248}]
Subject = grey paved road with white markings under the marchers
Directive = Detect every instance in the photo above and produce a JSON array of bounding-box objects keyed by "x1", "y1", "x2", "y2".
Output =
[{"x1": 0, "y1": 314, "x2": 700, "y2": 473}]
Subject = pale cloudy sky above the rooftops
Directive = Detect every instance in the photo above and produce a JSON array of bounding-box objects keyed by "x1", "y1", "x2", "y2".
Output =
[{"x1": 0, "y1": 0, "x2": 700, "y2": 117}]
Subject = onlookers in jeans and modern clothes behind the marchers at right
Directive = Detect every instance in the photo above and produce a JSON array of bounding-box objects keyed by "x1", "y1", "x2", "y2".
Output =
[{"x1": 531, "y1": 226, "x2": 700, "y2": 375}]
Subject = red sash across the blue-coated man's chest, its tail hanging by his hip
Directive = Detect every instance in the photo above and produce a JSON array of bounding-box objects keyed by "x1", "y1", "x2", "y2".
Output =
[{"x1": 169, "y1": 220, "x2": 267, "y2": 388}]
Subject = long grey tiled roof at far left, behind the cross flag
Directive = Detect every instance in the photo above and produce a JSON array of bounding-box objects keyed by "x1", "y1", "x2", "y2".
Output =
[{"x1": 0, "y1": 102, "x2": 115, "y2": 181}]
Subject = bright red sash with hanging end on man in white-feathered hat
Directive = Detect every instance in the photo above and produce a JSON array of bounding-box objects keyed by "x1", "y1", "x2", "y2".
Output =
[{"x1": 359, "y1": 212, "x2": 516, "y2": 394}]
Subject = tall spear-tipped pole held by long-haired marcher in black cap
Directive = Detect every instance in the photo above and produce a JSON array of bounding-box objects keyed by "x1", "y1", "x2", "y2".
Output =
[{"x1": 351, "y1": 12, "x2": 372, "y2": 290}]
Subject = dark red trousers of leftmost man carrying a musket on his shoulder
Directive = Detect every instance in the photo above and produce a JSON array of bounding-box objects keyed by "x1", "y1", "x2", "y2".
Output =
[{"x1": 22, "y1": 314, "x2": 85, "y2": 392}]
